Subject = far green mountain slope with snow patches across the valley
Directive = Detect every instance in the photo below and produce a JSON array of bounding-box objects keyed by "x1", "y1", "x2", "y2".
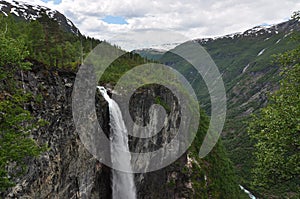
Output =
[{"x1": 150, "y1": 19, "x2": 300, "y2": 196}]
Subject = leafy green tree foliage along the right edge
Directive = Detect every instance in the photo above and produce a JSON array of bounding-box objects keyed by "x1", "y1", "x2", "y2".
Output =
[{"x1": 248, "y1": 13, "x2": 300, "y2": 198}]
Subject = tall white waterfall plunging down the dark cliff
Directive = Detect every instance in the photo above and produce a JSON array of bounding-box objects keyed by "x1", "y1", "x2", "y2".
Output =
[{"x1": 97, "y1": 86, "x2": 136, "y2": 199}]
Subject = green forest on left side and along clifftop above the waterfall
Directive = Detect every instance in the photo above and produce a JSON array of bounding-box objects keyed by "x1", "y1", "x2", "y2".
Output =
[{"x1": 0, "y1": 14, "x2": 144, "y2": 191}]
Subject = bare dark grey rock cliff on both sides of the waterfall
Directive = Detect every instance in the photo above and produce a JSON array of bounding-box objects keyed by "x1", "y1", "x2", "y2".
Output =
[{"x1": 4, "y1": 63, "x2": 197, "y2": 198}]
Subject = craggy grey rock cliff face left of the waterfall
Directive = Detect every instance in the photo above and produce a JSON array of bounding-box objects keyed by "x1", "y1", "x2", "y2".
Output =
[{"x1": 5, "y1": 64, "x2": 110, "y2": 198}]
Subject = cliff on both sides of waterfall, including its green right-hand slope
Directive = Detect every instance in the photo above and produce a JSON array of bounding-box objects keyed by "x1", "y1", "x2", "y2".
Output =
[{"x1": 0, "y1": 63, "x2": 244, "y2": 199}]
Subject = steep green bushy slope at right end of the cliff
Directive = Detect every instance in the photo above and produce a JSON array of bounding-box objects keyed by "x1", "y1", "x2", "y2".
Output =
[{"x1": 188, "y1": 108, "x2": 248, "y2": 199}]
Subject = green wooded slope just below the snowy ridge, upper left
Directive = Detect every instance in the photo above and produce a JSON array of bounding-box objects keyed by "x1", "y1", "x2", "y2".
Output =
[{"x1": 0, "y1": 14, "x2": 100, "y2": 69}]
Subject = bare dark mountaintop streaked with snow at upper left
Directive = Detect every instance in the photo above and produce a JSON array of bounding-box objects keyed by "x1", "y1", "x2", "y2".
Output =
[{"x1": 0, "y1": 0, "x2": 80, "y2": 35}]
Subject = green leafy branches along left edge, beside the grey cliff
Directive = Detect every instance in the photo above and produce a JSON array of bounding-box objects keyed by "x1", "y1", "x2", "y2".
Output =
[{"x1": 0, "y1": 22, "x2": 45, "y2": 191}]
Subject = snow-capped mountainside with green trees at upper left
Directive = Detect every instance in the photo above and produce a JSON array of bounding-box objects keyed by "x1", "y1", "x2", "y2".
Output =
[{"x1": 0, "y1": 0, "x2": 101, "y2": 68}]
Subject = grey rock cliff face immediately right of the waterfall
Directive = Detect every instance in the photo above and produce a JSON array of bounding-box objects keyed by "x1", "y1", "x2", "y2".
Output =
[{"x1": 130, "y1": 85, "x2": 193, "y2": 199}]
